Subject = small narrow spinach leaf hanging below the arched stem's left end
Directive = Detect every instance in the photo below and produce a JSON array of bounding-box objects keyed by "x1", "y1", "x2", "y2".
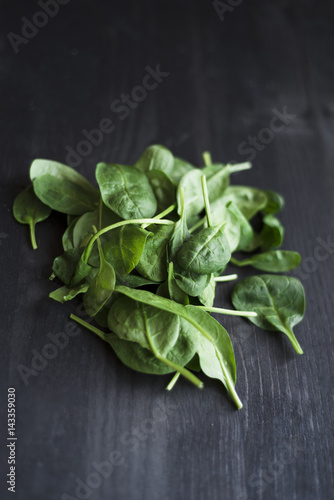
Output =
[{"x1": 84, "y1": 245, "x2": 116, "y2": 316}]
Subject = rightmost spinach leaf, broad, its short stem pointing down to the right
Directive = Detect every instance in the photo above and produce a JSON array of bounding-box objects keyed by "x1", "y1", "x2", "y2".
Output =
[{"x1": 232, "y1": 274, "x2": 305, "y2": 354}]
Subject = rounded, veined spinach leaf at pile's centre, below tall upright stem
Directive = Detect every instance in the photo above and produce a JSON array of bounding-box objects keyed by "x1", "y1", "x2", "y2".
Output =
[{"x1": 176, "y1": 223, "x2": 231, "y2": 274}]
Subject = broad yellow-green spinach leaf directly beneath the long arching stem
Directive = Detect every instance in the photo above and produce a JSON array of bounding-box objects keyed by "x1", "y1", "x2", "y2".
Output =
[{"x1": 103, "y1": 225, "x2": 150, "y2": 276}]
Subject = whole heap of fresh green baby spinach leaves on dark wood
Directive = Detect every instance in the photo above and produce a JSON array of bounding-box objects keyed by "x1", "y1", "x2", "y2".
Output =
[{"x1": 13, "y1": 145, "x2": 305, "y2": 408}]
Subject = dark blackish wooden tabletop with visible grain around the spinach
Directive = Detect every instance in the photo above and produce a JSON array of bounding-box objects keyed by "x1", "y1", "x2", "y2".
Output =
[{"x1": 0, "y1": 0, "x2": 334, "y2": 500}]
